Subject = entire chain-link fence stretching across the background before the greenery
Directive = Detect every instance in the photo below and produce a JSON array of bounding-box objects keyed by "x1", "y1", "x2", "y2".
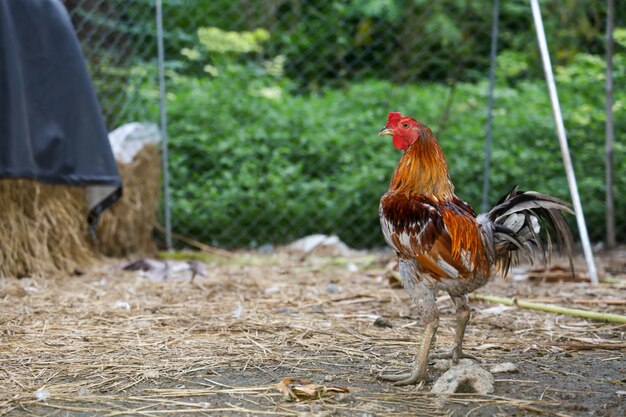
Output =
[{"x1": 65, "y1": 0, "x2": 626, "y2": 247}]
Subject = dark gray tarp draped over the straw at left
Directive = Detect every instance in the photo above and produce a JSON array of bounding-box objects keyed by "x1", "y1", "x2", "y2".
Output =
[{"x1": 0, "y1": 0, "x2": 122, "y2": 231}]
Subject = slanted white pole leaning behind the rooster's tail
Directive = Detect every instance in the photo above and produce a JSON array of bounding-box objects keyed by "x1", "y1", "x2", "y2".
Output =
[{"x1": 530, "y1": 0, "x2": 598, "y2": 284}]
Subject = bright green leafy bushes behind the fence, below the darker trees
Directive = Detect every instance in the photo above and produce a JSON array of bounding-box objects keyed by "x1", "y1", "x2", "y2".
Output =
[{"x1": 160, "y1": 30, "x2": 626, "y2": 247}]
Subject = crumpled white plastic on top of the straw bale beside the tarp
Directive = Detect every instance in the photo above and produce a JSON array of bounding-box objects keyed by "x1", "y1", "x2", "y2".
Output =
[{"x1": 109, "y1": 122, "x2": 161, "y2": 164}]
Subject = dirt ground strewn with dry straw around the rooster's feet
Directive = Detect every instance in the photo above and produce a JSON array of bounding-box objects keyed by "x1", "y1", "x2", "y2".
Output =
[{"x1": 0, "y1": 245, "x2": 626, "y2": 417}]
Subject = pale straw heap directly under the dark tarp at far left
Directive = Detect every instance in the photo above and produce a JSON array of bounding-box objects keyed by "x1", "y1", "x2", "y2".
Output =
[{"x1": 0, "y1": 179, "x2": 95, "y2": 277}]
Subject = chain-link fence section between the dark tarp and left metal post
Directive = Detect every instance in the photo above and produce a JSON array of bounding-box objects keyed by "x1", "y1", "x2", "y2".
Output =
[{"x1": 63, "y1": 0, "x2": 158, "y2": 130}]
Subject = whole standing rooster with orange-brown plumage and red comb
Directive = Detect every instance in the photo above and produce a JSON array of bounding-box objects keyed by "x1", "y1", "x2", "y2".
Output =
[{"x1": 379, "y1": 112, "x2": 572, "y2": 385}]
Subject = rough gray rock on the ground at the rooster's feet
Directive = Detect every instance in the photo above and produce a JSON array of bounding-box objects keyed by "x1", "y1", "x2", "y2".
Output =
[{"x1": 432, "y1": 365, "x2": 494, "y2": 395}]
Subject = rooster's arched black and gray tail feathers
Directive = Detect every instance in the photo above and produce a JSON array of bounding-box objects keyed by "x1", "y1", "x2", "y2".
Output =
[{"x1": 478, "y1": 187, "x2": 574, "y2": 275}]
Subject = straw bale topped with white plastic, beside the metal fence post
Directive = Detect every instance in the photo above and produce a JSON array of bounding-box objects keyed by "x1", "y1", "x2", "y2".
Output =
[{"x1": 97, "y1": 144, "x2": 161, "y2": 256}]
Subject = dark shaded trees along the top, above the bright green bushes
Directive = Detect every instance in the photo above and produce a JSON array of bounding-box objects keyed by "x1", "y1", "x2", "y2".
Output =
[{"x1": 155, "y1": 0, "x2": 626, "y2": 91}]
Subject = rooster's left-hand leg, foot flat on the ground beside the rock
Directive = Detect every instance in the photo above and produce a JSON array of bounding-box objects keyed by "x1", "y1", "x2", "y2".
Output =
[{"x1": 379, "y1": 283, "x2": 439, "y2": 386}]
